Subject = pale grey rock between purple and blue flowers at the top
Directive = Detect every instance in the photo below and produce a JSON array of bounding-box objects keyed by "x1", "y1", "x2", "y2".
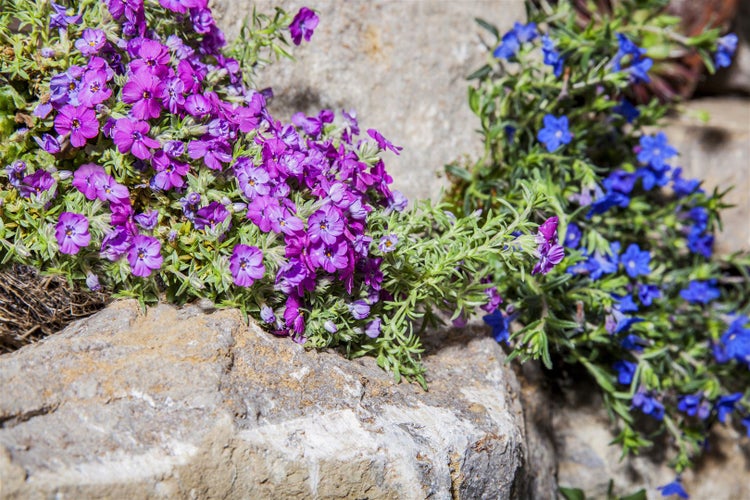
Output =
[{"x1": 213, "y1": 0, "x2": 525, "y2": 200}]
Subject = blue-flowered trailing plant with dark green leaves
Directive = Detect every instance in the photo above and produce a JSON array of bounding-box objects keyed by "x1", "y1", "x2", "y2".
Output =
[{"x1": 447, "y1": 0, "x2": 750, "y2": 494}]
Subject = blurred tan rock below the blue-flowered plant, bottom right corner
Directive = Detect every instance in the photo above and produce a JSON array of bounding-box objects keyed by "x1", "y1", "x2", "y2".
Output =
[{"x1": 550, "y1": 370, "x2": 750, "y2": 500}]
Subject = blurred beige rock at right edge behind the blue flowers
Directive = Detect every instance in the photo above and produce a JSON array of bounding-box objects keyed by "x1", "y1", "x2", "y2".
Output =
[{"x1": 667, "y1": 97, "x2": 750, "y2": 255}]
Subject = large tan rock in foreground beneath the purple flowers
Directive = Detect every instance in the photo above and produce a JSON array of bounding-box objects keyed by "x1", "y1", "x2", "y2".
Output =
[{"x1": 0, "y1": 301, "x2": 554, "y2": 498}]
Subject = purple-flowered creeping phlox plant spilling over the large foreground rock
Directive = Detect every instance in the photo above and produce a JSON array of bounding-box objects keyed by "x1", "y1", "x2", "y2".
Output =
[{"x1": 0, "y1": 0, "x2": 548, "y2": 385}]
